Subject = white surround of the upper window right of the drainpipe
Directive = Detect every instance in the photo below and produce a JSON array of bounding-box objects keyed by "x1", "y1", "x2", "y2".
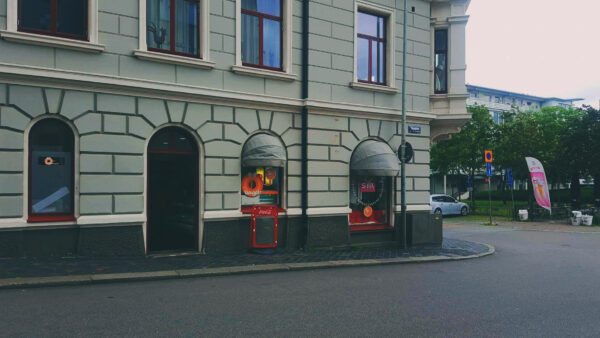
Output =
[{"x1": 350, "y1": 1, "x2": 398, "y2": 94}]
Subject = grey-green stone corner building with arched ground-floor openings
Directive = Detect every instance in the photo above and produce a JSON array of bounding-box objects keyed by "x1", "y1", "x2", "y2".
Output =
[{"x1": 0, "y1": 0, "x2": 469, "y2": 256}]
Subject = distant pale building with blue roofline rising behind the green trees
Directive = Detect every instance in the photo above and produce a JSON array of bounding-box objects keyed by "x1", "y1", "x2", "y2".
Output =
[{"x1": 467, "y1": 84, "x2": 583, "y2": 123}]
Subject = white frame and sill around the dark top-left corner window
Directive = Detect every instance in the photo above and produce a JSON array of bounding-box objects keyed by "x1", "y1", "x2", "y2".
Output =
[{"x1": 0, "y1": 0, "x2": 104, "y2": 53}]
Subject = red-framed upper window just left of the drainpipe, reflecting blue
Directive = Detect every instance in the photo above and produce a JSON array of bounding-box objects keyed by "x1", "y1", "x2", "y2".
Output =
[{"x1": 242, "y1": 0, "x2": 282, "y2": 70}]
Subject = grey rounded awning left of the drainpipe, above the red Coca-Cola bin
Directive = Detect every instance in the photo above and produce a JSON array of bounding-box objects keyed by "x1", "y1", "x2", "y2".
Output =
[{"x1": 242, "y1": 134, "x2": 286, "y2": 167}]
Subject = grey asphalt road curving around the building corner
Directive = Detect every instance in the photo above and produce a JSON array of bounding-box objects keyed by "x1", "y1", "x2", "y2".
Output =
[{"x1": 0, "y1": 223, "x2": 600, "y2": 337}]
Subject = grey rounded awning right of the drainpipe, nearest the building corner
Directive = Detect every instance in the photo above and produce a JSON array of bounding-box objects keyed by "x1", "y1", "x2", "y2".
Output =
[{"x1": 350, "y1": 140, "x2": 400, "y2": 176}]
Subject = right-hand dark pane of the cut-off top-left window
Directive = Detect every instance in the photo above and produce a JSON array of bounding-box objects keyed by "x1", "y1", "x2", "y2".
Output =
[{"x1": 56, "y1": 0, "x2": 88, "y2": 37}]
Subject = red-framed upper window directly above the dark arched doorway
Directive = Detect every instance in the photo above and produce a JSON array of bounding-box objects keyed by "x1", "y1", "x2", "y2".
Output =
[{"x1": 146, "y1": 0, "x2": 200, "y2": 57}]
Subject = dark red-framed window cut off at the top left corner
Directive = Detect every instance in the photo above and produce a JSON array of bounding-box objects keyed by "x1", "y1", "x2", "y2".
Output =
[{"x1": 18, "y1": 0, "x2": 88, "y2": 40}]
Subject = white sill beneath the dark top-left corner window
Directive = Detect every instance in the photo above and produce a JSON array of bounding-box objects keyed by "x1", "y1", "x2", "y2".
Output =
[{"x1": 0, "y1": 31, "x2": 104, "y2": 53}]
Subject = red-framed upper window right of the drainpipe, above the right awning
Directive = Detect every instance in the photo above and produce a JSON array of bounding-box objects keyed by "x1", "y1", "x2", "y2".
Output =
[{"x1": 356, "y1": 12, "x2": 386, "y2": 85}]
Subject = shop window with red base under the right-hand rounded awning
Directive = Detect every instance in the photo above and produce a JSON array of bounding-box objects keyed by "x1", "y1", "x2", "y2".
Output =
[{"x1": 350, "y1": 175, "x2": 392, "y2": 230}]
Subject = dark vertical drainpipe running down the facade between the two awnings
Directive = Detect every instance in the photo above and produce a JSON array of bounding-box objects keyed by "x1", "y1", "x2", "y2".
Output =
[{"x1": 301, "y1": 0, "x2": 309, "y2": 250}]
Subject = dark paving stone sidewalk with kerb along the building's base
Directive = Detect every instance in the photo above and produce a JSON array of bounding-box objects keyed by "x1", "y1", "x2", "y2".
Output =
[{"x1": 0, "y1": 238, "x2": 490, "y2": 280}]
